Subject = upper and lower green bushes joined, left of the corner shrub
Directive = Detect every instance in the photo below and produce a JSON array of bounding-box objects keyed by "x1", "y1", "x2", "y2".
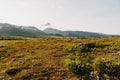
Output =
[{"x1": 65, "y1": 43, "x2": 95, "y2": 76}]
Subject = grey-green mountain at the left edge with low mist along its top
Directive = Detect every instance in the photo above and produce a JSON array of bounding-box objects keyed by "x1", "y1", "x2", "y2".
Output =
[{"x1": 0, "y1": 23, "x2": 47, "y2": 37}]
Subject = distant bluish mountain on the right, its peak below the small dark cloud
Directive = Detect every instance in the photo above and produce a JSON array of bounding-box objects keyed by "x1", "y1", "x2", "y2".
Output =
[{"x1": 43, "y1": 28, "x2": 108, "y2": 37}]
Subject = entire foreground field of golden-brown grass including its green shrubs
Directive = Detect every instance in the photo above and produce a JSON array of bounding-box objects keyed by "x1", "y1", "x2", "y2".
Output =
[{"x1": 0, "y1": 37, "x2": 120, "y2": 80}]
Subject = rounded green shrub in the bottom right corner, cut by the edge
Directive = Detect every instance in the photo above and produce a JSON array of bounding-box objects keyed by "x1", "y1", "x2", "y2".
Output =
[{"x1": 94, "y1": 58, "x2": 120, "y2": 79}]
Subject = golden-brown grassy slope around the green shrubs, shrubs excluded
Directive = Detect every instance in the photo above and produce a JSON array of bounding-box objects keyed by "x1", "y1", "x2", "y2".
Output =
[{"x1": 0, "y1": 37, "x2": 120, "y2": 80}]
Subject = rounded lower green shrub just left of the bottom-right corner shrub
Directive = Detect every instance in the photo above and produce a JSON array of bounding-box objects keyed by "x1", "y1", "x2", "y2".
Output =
[{"x1": 65, "y1": 58, "x2": 92, "y2": 76}]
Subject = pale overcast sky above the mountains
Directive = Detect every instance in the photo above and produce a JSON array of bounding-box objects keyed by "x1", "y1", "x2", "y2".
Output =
[{"x1": 0, "y1": 0, "x2": 120, "y2": 34}]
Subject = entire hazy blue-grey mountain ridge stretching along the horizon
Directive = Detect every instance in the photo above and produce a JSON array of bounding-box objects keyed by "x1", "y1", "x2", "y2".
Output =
[{"x1": 0, "y1": 23, "x2": 117, "y2": 37}]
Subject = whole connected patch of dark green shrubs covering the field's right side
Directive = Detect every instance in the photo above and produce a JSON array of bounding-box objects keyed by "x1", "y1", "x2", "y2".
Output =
[{"x1": 65, "y1": 42, "x2": 120, "y2": 80}]
